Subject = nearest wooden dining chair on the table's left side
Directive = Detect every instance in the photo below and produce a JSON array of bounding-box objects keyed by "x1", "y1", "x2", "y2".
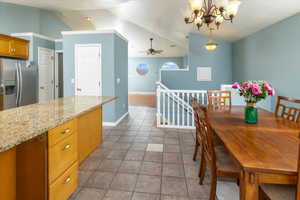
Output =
[{"x1": 195, "y1": 105, "x2": 240, "y2": 200}]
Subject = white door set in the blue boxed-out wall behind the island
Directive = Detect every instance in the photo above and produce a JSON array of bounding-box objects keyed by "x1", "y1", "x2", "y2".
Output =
[{"x1": 75, "y1": 44, "x2": 102, "y2": 96}]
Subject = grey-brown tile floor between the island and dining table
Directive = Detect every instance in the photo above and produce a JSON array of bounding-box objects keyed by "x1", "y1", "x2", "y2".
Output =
[{"x1": 70, "y1": 107, "x2": 213, "y2": 200}]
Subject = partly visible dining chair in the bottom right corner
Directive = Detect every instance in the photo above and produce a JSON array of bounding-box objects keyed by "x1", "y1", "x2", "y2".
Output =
[{"x1": 259, "y1": 133, "x2": 300, "y2": 200}]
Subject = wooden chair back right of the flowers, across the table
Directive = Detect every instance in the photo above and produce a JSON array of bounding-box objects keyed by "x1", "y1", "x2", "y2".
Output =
[{"x1": 275, "y1": 96, "x2": 300, "y2": 123}]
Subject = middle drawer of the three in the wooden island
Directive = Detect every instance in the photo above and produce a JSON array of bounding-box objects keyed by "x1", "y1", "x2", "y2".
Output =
[{"x1": 48, "y1": 133, "x2": 78, "y2": 183}]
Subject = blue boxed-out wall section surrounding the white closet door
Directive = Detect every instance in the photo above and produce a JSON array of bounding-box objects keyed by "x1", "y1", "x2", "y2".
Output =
[{"x1": 63, "y1": 33, "x2": 128, "y2": 122}]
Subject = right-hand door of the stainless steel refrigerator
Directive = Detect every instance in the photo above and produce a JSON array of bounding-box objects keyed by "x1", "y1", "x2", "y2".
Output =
[{"x1": 19, "y1": 61, "x2": 37, "y2": 106}]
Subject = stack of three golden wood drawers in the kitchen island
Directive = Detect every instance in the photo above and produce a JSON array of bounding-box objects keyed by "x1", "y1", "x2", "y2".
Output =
[{"x1": 48, "y1": 119, "x2": 78, "y2": 200}]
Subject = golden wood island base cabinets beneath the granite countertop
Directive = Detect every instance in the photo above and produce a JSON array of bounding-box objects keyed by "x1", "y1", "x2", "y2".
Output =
[{"x1": 13, "y1": 107, "x2": 102, "y2": 200}]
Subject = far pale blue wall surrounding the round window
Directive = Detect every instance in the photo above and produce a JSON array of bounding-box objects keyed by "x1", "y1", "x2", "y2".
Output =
[{"x1": 128, "y1": 57, "x2": 186, "y2": 92}]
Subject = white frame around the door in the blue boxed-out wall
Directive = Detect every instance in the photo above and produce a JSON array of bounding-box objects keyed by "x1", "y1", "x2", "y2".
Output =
[{"x1": 74, "y1": 43, "x2": 103, "y2": 96}]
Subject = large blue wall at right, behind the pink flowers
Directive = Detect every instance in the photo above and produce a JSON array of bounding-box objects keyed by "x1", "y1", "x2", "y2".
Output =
[{"x1": 233, "y1": 14, "x2": 300, "y2": 109}]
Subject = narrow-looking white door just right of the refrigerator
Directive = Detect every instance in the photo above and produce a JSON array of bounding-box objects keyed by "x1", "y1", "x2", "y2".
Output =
[{"x1": 38, "y1": 47, "x2": 54, "y2": 101}]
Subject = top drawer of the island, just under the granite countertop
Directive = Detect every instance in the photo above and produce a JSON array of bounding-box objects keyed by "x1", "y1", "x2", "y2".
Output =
[{"x1": 48, "y1": 119, "x2": 77, "y2": 147}]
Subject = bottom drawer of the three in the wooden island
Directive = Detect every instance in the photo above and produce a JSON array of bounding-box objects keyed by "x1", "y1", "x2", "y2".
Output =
[{"x1": 49, "y1": 162, "x2": 78, "y2": 200}]
